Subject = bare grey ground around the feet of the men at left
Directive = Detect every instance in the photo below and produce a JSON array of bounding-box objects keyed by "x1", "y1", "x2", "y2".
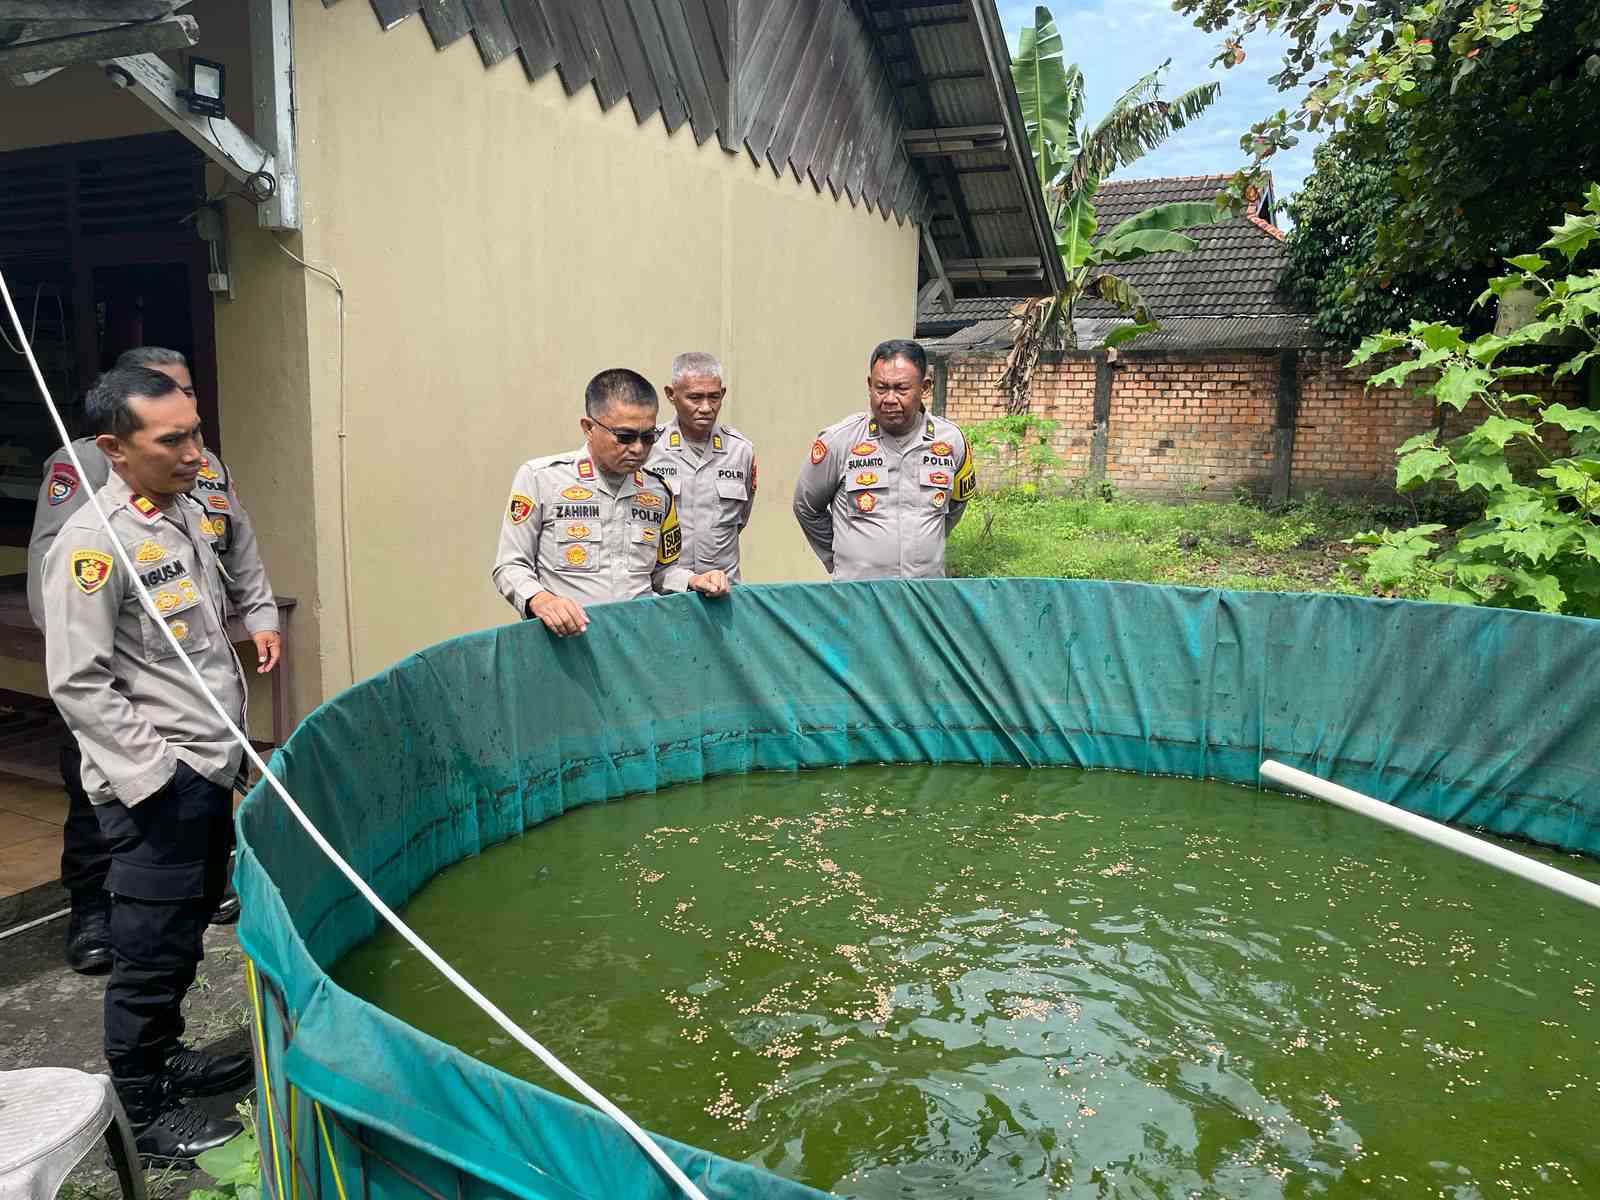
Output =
[{"x1": 0, "y1": 915, "x2": 253, "y2": 1200}]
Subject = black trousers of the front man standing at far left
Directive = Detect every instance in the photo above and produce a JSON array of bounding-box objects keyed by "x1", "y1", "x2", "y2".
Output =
[{"x1": 94, "y1": 763, "x2": 234, "y2": 1078}]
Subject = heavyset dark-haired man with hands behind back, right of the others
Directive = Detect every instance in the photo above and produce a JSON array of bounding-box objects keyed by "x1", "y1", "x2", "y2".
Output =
[{"x1": 794, "y1": 341, "x2": 974, "y2": 579}]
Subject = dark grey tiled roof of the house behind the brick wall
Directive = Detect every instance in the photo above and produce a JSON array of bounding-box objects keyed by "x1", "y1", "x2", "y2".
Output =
[{"x1": 917, "y1": 174, "x2": 1306, "y2": 336}]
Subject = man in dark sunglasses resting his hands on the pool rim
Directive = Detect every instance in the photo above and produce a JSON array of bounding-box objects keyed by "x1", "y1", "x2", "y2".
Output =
[{"x1": 493, "y1": 368, "x2": 730, "y2": 637}]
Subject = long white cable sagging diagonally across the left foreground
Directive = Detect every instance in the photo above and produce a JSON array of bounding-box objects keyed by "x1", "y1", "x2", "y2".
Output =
[{"x1": 0, "y1": 272, "x2": 706, "y2": 1200}]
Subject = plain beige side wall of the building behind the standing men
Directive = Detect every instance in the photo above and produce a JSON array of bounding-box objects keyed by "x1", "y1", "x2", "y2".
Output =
[{"x1": 294, "y1": 0, "x2": 917, "y2": 686}]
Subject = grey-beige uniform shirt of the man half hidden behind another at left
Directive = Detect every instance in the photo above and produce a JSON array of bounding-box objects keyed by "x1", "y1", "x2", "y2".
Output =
[{"x1": 27, "y1": 437, "x2": 278, "y2": 634}]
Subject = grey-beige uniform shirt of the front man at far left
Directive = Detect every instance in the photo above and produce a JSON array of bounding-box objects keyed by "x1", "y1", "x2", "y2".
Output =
[{"x1": 43, "y1": 475, "x2": 245, "y2": 805}]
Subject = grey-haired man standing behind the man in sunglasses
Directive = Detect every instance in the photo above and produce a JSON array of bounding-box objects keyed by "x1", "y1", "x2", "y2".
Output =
[{"x1": 645, "y1": 354, "x2": 755, "y2": 582}]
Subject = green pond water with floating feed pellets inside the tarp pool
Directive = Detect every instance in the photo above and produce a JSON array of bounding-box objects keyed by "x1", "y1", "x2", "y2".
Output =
[{"x1": 334, "y1": 766, "x2": 1600, "y2": 1200}]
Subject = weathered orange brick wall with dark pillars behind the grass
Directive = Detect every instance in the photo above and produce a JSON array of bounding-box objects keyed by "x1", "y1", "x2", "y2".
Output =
[{"x1": 944, "y1": 350, "x2": 1582, "y2": 498}]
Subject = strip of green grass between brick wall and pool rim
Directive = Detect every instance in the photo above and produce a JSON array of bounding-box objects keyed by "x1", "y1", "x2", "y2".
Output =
[{"x1": 947, "y1": 490, "x2": 1413, "y2": 594}]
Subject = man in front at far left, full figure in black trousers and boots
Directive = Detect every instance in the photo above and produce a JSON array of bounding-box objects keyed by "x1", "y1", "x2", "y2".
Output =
[{"x1": 43, "y1": 366, "x2": 251, "y2": 1163}]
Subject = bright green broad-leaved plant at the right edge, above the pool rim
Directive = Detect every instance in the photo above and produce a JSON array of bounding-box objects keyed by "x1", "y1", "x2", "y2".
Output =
[{"x1": 1352, "y1": 184, "x2": 1600, "y2": 616}]
